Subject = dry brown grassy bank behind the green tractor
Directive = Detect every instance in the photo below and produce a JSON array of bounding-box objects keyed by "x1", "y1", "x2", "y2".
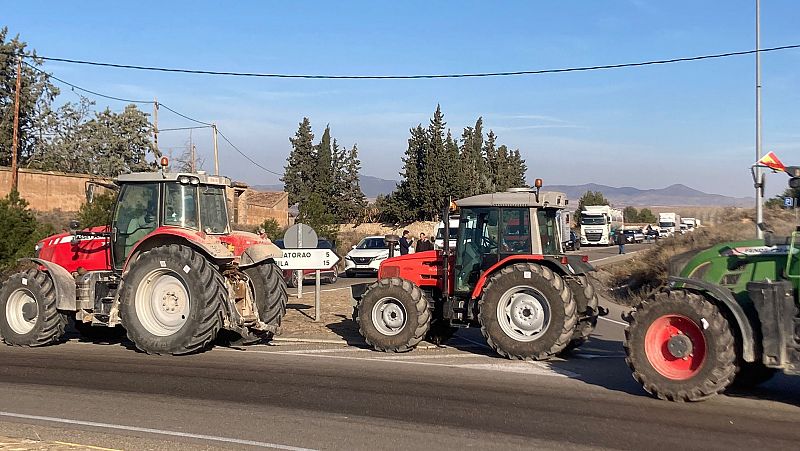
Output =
[{"x1": 598, "y1": 209, "x2": 795, "y2": 305}]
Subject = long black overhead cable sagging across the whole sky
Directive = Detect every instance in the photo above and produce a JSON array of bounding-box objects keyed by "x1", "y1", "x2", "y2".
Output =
[{"x1": 10, "y1": 44, "x2": 800, "y2": 80}]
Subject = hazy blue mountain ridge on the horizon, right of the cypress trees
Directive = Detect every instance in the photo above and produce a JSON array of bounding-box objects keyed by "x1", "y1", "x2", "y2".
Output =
[{"x1": 545, "y1": 183, "x2": 754, "y2": 207}]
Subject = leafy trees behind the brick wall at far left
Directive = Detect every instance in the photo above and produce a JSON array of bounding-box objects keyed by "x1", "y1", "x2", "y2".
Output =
[{"x1": 0, "y1": 28, "x2": 161, "y2": 177}]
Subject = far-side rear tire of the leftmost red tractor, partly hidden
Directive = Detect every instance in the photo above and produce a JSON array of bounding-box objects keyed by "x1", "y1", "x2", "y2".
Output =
[{"x1": 244, "y1": 262, "x2": 289, "y2": 338}]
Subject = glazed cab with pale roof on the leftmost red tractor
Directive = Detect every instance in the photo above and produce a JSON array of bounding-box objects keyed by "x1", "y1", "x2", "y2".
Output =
[{"x1": 111, "y1": 172, "x2": 230, "y2": 269}]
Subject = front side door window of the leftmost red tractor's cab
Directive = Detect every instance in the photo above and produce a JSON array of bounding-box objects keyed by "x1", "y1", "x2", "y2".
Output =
[{"x1": 111, "y1": 183, "x2": 158, "y2": 268}]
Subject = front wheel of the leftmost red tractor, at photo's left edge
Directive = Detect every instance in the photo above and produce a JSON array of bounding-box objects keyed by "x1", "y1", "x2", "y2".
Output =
[{"x1": 0, "y1": 269, "x2": 67, "y2": 346}]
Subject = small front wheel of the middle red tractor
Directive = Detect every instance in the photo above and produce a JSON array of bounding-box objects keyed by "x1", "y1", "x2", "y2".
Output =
[{"x1": 356, "y1": 277, "x2": 431, "y2": 352}]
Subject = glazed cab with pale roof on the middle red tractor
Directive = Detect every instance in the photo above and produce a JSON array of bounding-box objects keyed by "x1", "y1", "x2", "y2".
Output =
[{"x1": 453, "y1": 189, "x2": 567, "y2": 293}]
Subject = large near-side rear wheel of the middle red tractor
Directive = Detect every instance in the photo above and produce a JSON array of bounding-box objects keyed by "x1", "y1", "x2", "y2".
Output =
[{"x1": 478, "y1": 263, "x2": 578, "y2": 360}]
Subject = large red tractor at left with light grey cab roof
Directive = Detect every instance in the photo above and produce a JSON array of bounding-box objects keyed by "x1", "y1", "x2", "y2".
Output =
[{"x1": 0, "y1": 168, "x2": 287, "y2": 355}]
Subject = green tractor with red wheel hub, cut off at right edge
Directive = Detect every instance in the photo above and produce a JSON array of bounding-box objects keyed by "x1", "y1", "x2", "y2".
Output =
[{"x1": 624, "y1": 167, "x2": 800, "y2": 401}]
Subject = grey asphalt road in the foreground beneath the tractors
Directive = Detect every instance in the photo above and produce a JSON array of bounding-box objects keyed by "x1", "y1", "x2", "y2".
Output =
[{"x1": 0, "y1": 244, "x2": 800, "y2": 450}]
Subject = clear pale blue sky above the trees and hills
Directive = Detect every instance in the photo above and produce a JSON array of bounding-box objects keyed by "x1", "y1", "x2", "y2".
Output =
[{"x1": 6, "y1": 0, "x2": 800, "y2": 196}]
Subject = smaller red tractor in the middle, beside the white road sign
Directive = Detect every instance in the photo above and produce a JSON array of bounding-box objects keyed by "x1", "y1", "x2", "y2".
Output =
[{"x1": 352, "y1": 185, "x2": 607, "y2": 360}]
